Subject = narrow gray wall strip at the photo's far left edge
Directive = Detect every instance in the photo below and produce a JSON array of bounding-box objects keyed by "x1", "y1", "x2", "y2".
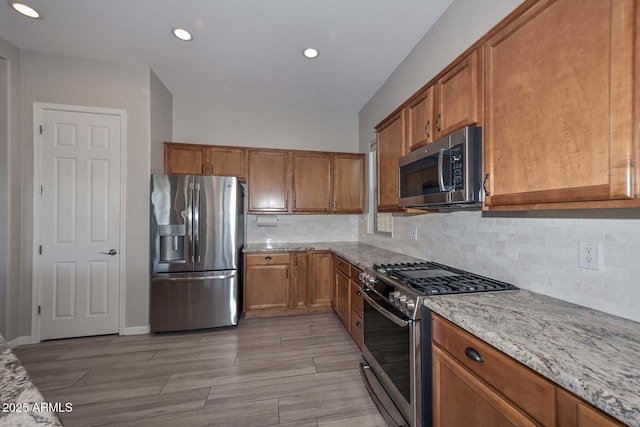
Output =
[{"x1": 0, "y1": 37, "x2": 22, "y2": 340}]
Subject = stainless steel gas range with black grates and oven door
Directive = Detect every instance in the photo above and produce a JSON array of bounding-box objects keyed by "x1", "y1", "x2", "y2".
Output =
[{"x1": 359, "y1": 262, "x2": 518, "y2": 427}]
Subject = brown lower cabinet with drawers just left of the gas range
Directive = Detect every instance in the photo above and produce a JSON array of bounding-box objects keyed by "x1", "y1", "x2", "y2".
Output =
[{"x1": 332, "y1": 255, "x2": 363, "y2": 348}]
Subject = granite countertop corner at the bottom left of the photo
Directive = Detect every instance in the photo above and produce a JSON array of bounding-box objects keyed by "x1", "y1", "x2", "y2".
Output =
[{"x1": 0, "y1": 335, "x2": 62, "y2": 427}]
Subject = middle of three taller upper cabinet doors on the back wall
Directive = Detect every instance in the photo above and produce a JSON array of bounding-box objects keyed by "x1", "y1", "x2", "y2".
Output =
[{"x1": 293, "y1": 152, "x2": 331, "y2": 212}]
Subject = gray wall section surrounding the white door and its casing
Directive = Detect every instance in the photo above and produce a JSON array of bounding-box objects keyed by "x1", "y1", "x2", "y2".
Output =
[{"x1": 19, "y1": 51, "x2": 150, "y2": 335}]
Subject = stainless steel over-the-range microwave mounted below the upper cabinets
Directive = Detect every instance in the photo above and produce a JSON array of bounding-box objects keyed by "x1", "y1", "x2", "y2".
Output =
[{"x1": 398, "y1": 126, "x2": 483, "y2": 209}]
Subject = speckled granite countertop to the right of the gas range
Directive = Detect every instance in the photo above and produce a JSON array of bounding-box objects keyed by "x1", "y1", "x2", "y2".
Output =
[{"x1": 424, "y1": 290, "x2": 640, "y2": 426}]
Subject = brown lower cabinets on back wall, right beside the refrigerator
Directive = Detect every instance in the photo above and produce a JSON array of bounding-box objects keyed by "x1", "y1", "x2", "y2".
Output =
[{"x1": 244, "y1": 251, "x2": 331, "y2": 317}]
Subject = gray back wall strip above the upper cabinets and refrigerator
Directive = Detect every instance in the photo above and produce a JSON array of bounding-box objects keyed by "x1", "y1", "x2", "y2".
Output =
[{"x1": 173, "y1": 94, "x2": 358, "y2": 152}]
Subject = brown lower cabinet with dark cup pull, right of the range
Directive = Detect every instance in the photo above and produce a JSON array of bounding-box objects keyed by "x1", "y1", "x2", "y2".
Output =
[{"x1": 432, "y1": 314, "x2": 623, "y2": 427}]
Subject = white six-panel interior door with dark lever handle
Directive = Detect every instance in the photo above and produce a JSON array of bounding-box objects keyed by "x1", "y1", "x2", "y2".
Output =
[{"x1": 35, "y1": 108, "x2": 122, "y2": 340}]
